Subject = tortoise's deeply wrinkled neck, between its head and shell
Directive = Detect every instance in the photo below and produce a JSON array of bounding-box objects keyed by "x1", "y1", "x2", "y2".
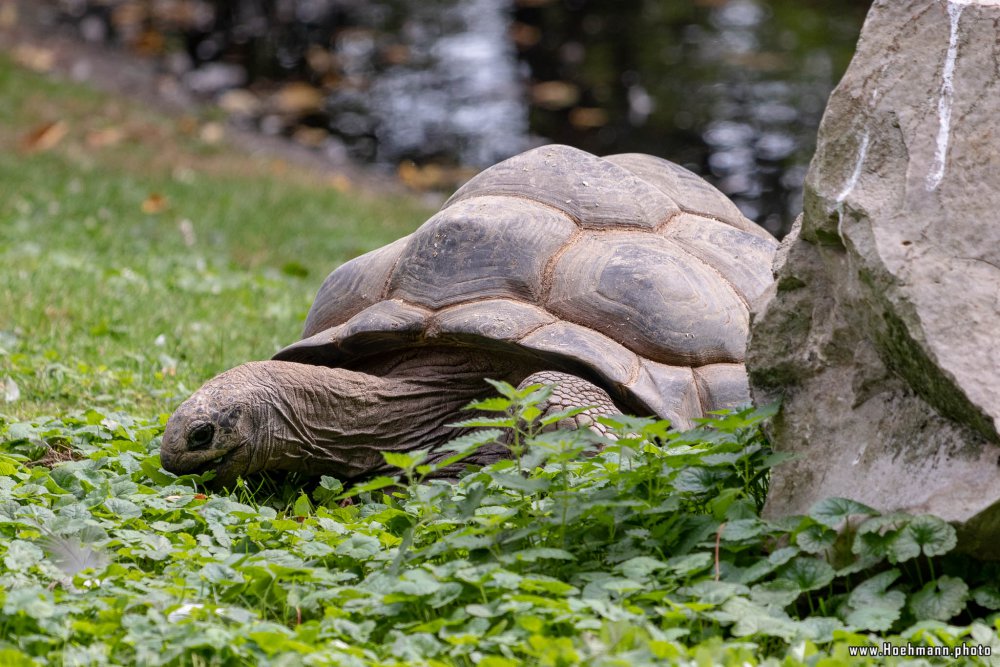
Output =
[{"x1": 262, "y1": 348, "x2": 529, "y2": 480}]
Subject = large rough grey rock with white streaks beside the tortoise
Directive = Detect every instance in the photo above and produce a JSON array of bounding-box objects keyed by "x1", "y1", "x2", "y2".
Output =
[{"x1": 748, "y1": 0, "x2": 1000, "y2": 558}]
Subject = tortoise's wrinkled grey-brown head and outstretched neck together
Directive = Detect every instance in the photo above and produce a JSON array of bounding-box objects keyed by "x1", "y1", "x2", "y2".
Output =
[{"x1": 161, "y1": 348, "x2": 527, "y2": 487}]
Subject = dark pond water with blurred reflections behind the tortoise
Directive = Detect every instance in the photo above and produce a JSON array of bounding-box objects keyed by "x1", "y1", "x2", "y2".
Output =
[{"x1": 52, "y1": 0, "x2": 869, "y2": 235}]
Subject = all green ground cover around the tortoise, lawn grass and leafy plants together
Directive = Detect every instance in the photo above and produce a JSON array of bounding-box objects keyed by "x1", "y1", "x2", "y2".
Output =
[{"x1": 0, "y1": 54, "x2": 1000, "y2": 667}]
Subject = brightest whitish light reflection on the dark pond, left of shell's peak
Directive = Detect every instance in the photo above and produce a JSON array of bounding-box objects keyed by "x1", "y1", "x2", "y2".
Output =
[{"x1": 362, "y1": 0, "x2": 528, "y2": 166}]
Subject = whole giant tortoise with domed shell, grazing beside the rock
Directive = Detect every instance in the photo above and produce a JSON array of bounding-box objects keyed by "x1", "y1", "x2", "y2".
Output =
[{"x1": 161, "y1": 145, "x2": 777, "y2": 486}]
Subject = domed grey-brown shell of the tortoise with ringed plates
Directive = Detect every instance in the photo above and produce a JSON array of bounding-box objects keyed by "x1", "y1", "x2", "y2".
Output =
[{"x1": 274, "y1": 145, "x2": 777, "y2": 427}]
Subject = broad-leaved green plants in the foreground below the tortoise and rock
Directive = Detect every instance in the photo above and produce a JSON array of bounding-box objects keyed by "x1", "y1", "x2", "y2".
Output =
[{"x1": 0, "y1": 394, "x2": 1000, "y2": 667}]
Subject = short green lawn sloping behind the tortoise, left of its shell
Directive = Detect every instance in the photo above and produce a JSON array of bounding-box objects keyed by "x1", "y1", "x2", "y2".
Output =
[{"x1": 0, "y1": 52, "x2": 428, "y2": 417}]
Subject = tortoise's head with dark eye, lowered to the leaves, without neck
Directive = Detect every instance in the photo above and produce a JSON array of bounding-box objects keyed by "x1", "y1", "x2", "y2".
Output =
[{"x1": 160, "y1": 362, "x2": 274, "y2": 488}]
